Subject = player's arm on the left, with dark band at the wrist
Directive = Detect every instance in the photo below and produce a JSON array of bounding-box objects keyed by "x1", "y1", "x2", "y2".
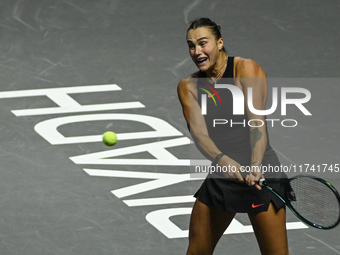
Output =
[{"x1": 177, "y1": 76, "x2": 243, "y2": 181}]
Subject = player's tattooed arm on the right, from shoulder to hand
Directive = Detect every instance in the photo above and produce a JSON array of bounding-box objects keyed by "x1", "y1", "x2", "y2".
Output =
[{"x1": 237, "y1": 59, "x2": 268, "y2": 189}]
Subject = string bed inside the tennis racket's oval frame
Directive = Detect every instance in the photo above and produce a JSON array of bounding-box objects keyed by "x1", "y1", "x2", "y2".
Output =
[{"x1": 286, "y1": 178, "x2": 340, "y2": 227}]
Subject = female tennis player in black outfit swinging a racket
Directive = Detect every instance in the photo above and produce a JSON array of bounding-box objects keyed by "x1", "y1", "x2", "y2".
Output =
[{"x1": 178, "y1": 18, "x2": 288, "y2": 255}]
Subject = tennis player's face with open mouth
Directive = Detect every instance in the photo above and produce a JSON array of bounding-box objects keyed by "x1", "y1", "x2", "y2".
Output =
[{"x1": 187, "y1": 27, "x2": 223, "y2": 72}]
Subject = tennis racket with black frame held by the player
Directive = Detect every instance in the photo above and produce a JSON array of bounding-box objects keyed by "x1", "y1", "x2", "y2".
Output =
[{"x1": 259, "y1": 175, "x2": 340, "y2": 229}]
